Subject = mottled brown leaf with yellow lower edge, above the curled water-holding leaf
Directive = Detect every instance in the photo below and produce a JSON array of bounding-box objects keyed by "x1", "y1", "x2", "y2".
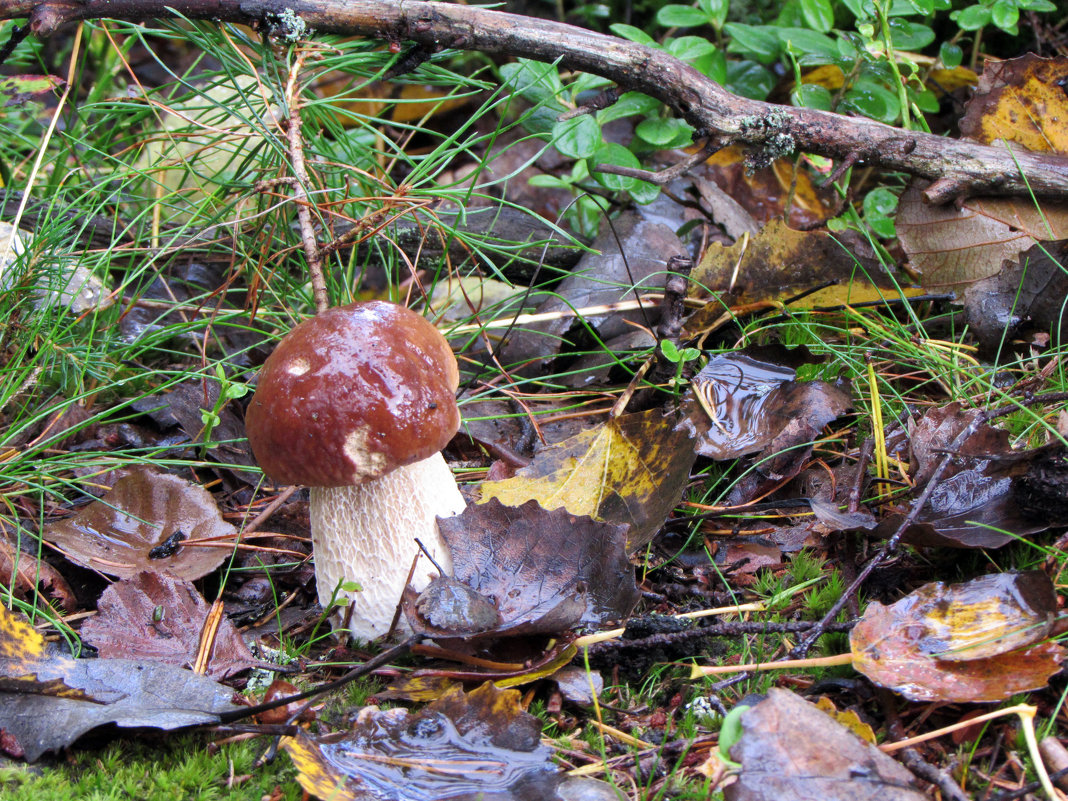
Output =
[{"x1": 686, "y1": 220, "x2": 916, "y2": 322}]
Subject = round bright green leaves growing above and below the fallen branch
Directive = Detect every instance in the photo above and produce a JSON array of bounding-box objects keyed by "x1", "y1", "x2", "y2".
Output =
[{"x1": 501, "y1": 0, "x2": 1056, "y2": 236}]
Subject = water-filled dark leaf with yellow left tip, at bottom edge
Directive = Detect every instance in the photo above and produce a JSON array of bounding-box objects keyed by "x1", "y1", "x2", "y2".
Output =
[{"x1": 284, "y1": 682, "x2": 563, "y2": 801}]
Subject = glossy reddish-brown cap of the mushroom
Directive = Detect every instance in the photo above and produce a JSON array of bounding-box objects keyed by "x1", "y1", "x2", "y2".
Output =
[{"x1": 246, "y1": 301, "x2": 460, "y2": 487}]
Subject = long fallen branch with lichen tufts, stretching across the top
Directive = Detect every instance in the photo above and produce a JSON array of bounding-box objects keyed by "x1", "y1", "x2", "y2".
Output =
[{"x1": 0, "y1": 0, "x2": 1068, "y2": 203}]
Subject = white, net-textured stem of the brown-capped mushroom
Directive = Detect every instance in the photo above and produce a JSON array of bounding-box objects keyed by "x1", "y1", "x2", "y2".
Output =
[{"x1": 311, "y1": 453, "x2": 466, "y2": 640}]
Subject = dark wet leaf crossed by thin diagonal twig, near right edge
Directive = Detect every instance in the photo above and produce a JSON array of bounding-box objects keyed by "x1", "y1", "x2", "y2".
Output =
[{"x1": 878, "y1": 403, "x2": 1055, "y2": 548}]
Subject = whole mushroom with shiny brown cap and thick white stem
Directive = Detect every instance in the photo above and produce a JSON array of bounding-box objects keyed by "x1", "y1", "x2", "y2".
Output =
[{"x1": 246, "y1": 301, "x2": 465, "y2": 639}]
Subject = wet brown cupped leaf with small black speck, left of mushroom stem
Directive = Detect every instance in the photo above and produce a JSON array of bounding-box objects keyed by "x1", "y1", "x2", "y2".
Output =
[{"x1": 44, "y1": 468, "x2": 234, "y2": 581}]
